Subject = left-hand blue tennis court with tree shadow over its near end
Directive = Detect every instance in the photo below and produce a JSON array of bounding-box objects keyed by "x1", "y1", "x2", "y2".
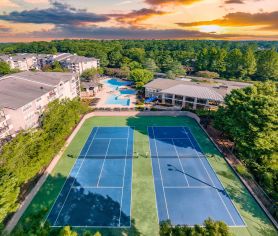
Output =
[{"x1": 47, "y1": 127, "x2": 133, "y2": 228}]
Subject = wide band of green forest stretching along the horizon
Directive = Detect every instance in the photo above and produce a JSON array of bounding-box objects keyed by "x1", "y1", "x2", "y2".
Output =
[{"x1": 0, "y1": 40, "x2": 278, "y2": 81}]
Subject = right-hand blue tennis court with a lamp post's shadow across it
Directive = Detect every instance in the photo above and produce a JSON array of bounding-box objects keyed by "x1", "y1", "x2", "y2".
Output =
[{"x1": 148, "y1": 127, "x2": 245, "y2": 226}]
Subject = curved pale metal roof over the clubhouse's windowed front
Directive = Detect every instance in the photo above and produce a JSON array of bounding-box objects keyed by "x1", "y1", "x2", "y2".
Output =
[{"x1": 161, "y1": 84, "x2": 224, "y2": 102}]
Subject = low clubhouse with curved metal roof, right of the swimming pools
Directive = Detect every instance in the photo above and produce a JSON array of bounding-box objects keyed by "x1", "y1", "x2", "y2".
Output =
[{"x1": 144, "y1": 78, "x2": 250, "y2": 110}]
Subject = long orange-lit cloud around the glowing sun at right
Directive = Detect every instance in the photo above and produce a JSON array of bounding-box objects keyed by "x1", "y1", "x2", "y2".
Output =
[{"x1": 177, "y1": 11, "x2": 278, "y2": 30}]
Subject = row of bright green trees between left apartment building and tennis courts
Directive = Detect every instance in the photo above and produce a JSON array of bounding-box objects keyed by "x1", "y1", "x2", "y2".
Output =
[{"x1": 0, "y1": 99, "x2": 87, "y2": 221}]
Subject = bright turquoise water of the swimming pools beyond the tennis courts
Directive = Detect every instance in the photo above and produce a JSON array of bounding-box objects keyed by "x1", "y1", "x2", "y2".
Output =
[{"x1": 104, "y1": 78, "x2": 136, "y2": 106}]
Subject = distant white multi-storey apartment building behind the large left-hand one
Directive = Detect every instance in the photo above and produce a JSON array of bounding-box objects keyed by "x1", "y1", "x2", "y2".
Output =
[{"x1": 53, "y1": 53, "x2": 99, "y2": 75}]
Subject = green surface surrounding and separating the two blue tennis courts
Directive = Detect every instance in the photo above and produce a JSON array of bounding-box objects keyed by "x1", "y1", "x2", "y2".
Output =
[{"x1": 16, "y1": 117, "x2": 277, "y2": 236}]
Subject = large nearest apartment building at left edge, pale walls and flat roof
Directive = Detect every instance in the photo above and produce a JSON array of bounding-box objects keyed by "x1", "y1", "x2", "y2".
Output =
[{"x1": 0, "y1": 71, "x2": 80, "y2": 138}]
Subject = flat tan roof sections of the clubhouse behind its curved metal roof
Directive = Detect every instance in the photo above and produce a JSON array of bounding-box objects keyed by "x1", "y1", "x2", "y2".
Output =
[{"x1": 144, "y1": 79, "x2": 251, "y2": 97}]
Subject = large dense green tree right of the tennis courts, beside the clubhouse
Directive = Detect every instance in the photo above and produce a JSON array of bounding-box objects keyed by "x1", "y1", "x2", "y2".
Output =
[{"x1": 214, "y1": 82, "x2": 278, "y2": 198}]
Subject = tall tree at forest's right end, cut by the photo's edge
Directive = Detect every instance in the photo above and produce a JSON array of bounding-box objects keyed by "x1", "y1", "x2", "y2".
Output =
[{"x1": 256, "y1": 50, "x2": 278, "y2": 81}]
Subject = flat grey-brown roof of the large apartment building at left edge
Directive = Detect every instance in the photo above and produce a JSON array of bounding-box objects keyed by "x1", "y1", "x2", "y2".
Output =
[{"x1": 0, "y1": 71, "x2": 74, "y2": 109}]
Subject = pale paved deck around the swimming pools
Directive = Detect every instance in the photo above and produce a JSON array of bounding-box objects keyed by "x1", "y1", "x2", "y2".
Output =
[{"x1": 96, "y1": 81, "x2": 136, "y2": 108}]
